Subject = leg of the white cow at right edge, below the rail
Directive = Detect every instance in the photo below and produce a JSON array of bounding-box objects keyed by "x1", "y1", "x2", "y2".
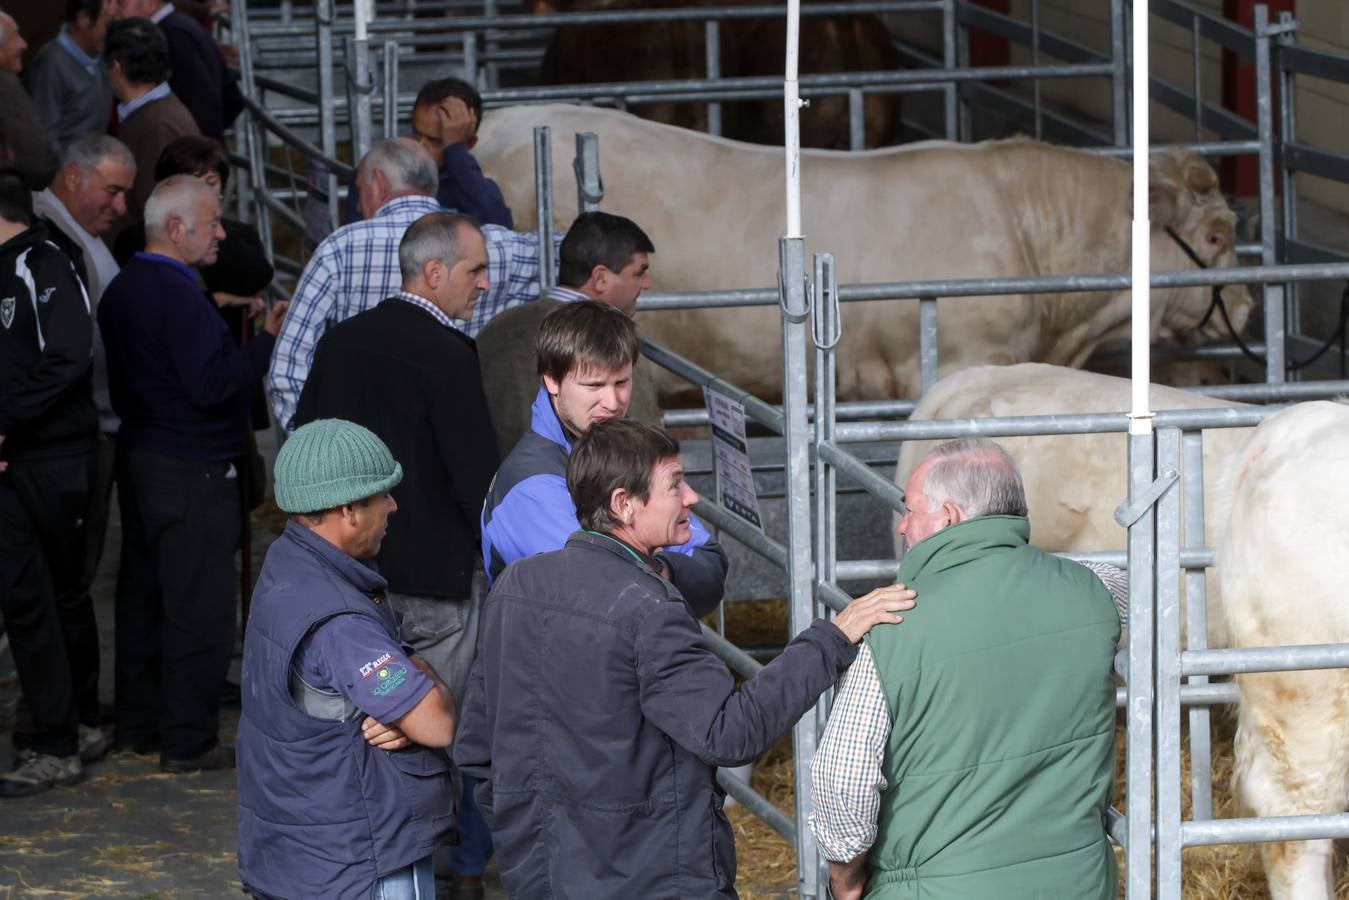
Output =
[{"x1": 1233, "y1": 671, "x2": 1349, "y2": 900}]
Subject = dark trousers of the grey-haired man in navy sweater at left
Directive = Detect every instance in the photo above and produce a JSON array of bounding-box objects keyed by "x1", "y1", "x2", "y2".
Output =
[{"x1": 115, "y1": 448, "x2": 239, "y2": 760}]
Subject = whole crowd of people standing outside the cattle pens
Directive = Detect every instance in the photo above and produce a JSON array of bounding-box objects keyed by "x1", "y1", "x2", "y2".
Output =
[{"x1": 0, "y1": 0, "x2": 1118, "y2": 899}]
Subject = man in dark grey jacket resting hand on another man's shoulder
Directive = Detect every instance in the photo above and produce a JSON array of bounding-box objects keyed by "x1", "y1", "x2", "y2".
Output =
[{"x1": 455, "y1": 418, "x2": 913, "y2": 900}]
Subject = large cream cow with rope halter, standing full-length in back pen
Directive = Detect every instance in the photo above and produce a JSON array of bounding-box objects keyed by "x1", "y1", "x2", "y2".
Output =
[{"x1": 475, "y1": 105, "x2": 1252, "y2": 399}]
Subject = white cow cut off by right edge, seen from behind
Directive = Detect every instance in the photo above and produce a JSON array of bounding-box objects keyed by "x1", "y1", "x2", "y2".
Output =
[{"x1": 1218, "y1": 402, "x2": 1349, "y2": 900}]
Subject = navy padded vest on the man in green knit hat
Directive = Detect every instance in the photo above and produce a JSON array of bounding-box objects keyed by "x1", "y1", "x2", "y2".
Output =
[{"x1": 236, "y1": 522, "x2": 455, "y2": 900}]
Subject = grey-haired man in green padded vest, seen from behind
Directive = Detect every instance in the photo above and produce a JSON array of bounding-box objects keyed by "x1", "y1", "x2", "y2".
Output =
[{"x1": 811, "y1": 440, "x2": 1120, "y2": 900}]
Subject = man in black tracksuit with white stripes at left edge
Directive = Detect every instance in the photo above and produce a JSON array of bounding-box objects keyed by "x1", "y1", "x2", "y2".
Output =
[{"x1": 0, "y1": 169, "x2": 103, "y2": 797}]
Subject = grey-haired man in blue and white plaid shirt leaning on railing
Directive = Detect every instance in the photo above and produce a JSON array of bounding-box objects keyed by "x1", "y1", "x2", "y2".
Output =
[{"x1": 267, "y1": 138, "x2": 563, "y2": 433}]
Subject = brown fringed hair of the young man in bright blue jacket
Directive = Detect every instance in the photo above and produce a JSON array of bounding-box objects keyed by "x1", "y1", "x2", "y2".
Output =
[{"x1": 534, "y1": 300, "x2": 642, "y2": 382}]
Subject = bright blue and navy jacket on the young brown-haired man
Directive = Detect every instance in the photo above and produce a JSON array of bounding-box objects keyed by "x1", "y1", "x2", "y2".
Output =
[{"x1": 483, "y1": 387, "x2": 727, "y2": 615}]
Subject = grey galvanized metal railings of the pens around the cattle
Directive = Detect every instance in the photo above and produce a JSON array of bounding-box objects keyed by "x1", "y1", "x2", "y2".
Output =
[{"x1": 213, "y1": 0, "x2": 1349, "y2": 897}]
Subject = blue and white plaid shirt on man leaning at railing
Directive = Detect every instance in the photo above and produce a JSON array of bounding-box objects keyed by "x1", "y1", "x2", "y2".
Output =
[{"x1": 267, "y1": 196, "x2": 563, "y2": 432}]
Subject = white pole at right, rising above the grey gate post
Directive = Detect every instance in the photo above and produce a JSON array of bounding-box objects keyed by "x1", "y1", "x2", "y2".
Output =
[{"x1": 1129, "y1": 0, "x2": 1152, "y2": 434}]
